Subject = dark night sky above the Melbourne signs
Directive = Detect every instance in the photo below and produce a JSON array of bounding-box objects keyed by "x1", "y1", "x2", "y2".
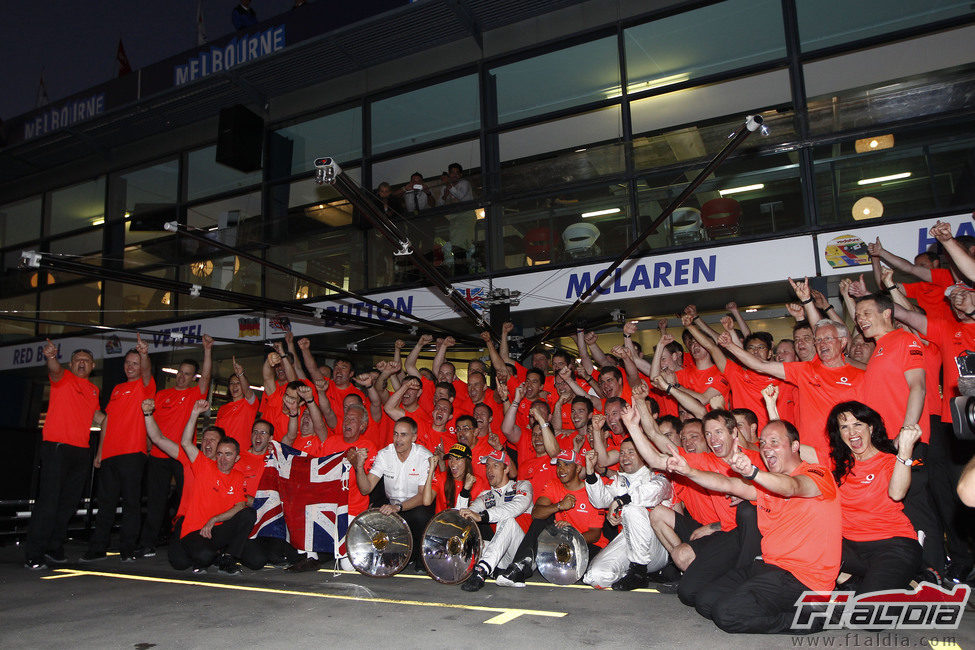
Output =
[{"x1": 0, "y1": 0, "x2": 294, "y2": 120}]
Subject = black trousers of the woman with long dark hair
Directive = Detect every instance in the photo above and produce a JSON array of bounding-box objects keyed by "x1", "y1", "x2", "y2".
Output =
[{"x1": 840, "y1": 537, "x2": 921, "y2": 594}]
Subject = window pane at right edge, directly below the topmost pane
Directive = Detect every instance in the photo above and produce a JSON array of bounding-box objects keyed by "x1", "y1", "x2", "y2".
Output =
[{"x1": 803, "y1": 26, "x2": 975, "y2": 99}]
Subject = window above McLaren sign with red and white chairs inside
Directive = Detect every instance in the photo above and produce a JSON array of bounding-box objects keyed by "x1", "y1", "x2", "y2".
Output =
[{"x1": 637, "y1": 152, "x2": 806, "y2": 249}]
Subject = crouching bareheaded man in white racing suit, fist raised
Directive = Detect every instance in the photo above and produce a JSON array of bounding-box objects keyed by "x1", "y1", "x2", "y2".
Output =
[{"x1": 582, "y1": 437, "x2": 673, "y2": 591}]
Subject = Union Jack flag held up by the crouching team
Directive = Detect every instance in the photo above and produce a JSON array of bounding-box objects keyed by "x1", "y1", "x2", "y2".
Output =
[{"x1": 251, "y1": 442, "x2": 351, "y2": 557}]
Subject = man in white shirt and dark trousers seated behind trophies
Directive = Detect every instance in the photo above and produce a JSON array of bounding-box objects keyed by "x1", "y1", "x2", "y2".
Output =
[{"x1": 355, "y1": 417, "x2": 433, "y2": 571}]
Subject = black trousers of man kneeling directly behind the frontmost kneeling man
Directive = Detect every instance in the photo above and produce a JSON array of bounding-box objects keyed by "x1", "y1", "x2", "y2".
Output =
[{"x1": 677, "y1": 501, "x2": 762, "y2": 607}]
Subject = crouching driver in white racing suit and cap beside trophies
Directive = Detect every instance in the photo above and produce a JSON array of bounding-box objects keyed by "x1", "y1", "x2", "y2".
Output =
[{"x1": 460, "y1": 449, "x2": 532, "y2": 591}]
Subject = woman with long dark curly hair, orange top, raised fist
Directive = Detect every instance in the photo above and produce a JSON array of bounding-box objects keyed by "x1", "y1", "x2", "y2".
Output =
[{"x1": 826, "y1": 402, "x2": 921, "y2": 593}]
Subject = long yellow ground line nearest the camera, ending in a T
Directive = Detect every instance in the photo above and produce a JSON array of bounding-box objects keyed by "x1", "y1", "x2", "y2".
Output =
[{"x1": 43, "y1": 569, "x2": 567, "y2": 625}]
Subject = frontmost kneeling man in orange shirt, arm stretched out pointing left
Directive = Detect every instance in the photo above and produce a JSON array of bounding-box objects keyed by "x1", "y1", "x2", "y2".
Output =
[{"x1": 667, "y1": 420, "x2": 842, "y2": 634}]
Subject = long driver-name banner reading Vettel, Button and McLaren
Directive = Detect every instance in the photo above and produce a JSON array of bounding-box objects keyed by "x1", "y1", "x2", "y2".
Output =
[{"x1": 0, "y1": 236, "x2": 815, "y2": 370}]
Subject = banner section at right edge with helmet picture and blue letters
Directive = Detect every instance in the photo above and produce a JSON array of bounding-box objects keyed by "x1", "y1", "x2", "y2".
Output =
[{"x1": 816, "y1": 214, "x2": 975, "y2": 275}]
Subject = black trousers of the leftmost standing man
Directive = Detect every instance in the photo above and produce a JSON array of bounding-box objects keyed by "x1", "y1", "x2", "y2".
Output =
[{"x1": 24, "y1": 440, "x2": 91, "y2": 560}]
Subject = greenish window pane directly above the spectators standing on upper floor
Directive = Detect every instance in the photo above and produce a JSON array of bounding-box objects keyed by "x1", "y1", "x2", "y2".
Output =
[{"x1": 371, "y1": 75, "x2": 481, "y2": 153}]
